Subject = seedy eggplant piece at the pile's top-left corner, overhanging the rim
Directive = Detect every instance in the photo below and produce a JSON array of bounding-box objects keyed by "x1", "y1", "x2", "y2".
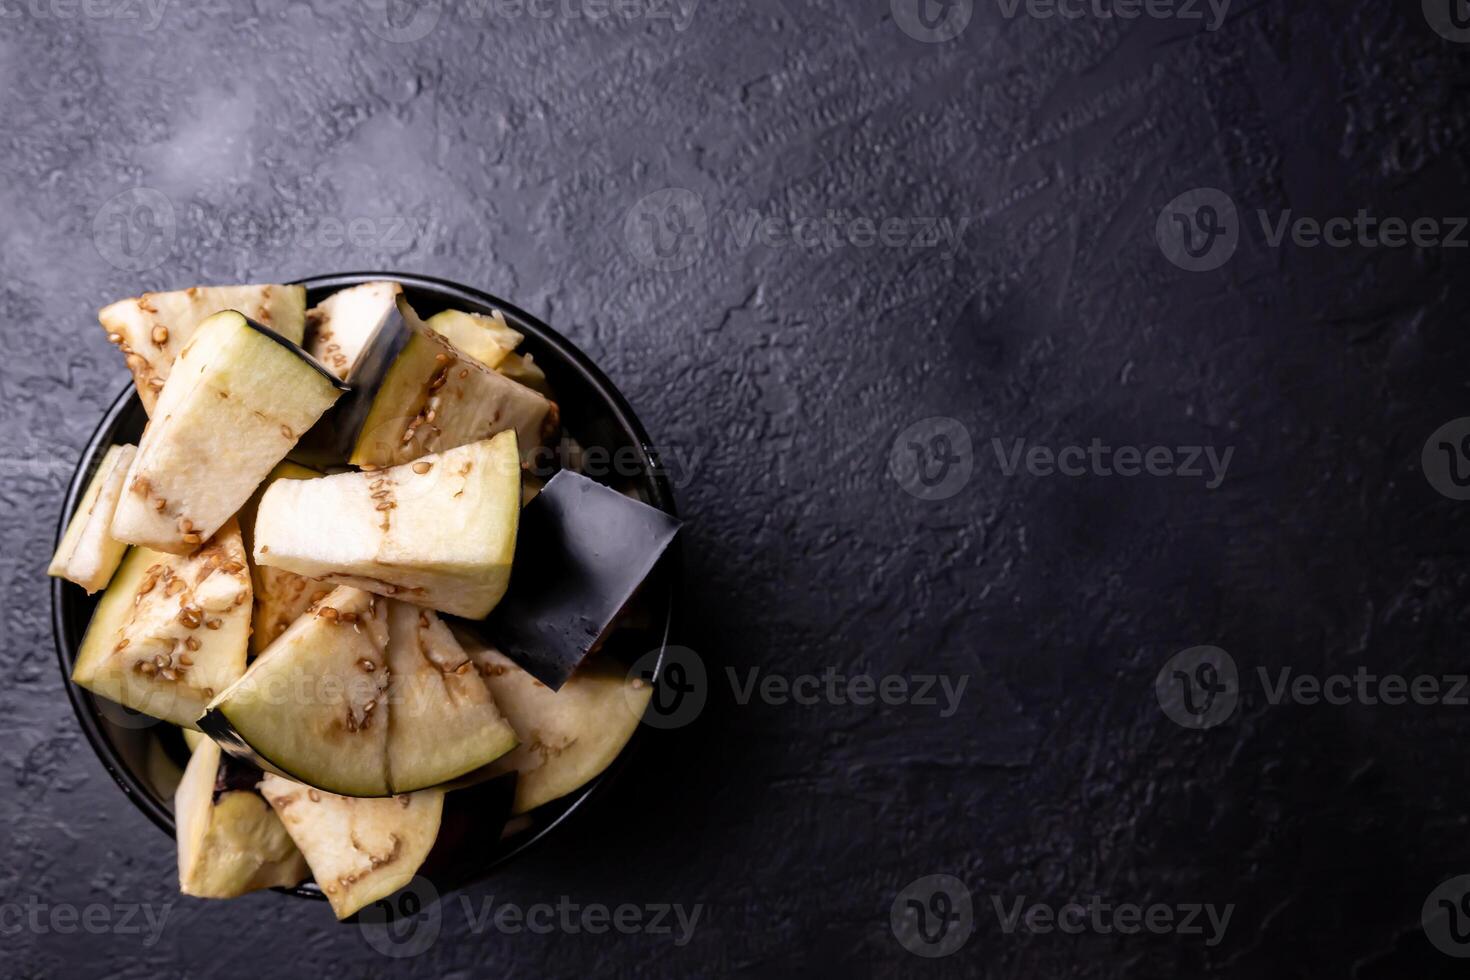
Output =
[{"x1": 97, "y1": 285, "x2": 306, "y2": 416}]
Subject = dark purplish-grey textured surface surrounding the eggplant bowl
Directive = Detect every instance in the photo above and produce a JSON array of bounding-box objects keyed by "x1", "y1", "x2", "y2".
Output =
[{"x1": 0, "y1": 0, "x2": 1470, "y2": 977}]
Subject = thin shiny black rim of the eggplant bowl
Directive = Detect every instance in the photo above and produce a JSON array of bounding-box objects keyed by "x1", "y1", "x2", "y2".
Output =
[{"x1": 51, "y1": 272, "x2": 682, "y2": 901}]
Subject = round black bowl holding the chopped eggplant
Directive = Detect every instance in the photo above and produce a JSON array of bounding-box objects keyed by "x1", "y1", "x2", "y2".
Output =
[{"x1": 51, "y1": 272, "x2": 679, "y2": 899}]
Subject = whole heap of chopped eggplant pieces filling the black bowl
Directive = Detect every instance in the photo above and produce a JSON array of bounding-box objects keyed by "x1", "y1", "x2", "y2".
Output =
[{"x1": 63, "y1": 274, "x2": 679, "y2": 918}]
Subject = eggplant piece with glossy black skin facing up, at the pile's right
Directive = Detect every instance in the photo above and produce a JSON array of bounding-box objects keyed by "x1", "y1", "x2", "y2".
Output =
[{"x1": 481, "y1": 470, "x2": 681, "y2": 691}]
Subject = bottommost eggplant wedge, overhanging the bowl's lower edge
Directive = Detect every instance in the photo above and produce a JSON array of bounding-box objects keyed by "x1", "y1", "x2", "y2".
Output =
[{"x1": 260, "y1": 773, "x2": 444, "y2": 918}]
